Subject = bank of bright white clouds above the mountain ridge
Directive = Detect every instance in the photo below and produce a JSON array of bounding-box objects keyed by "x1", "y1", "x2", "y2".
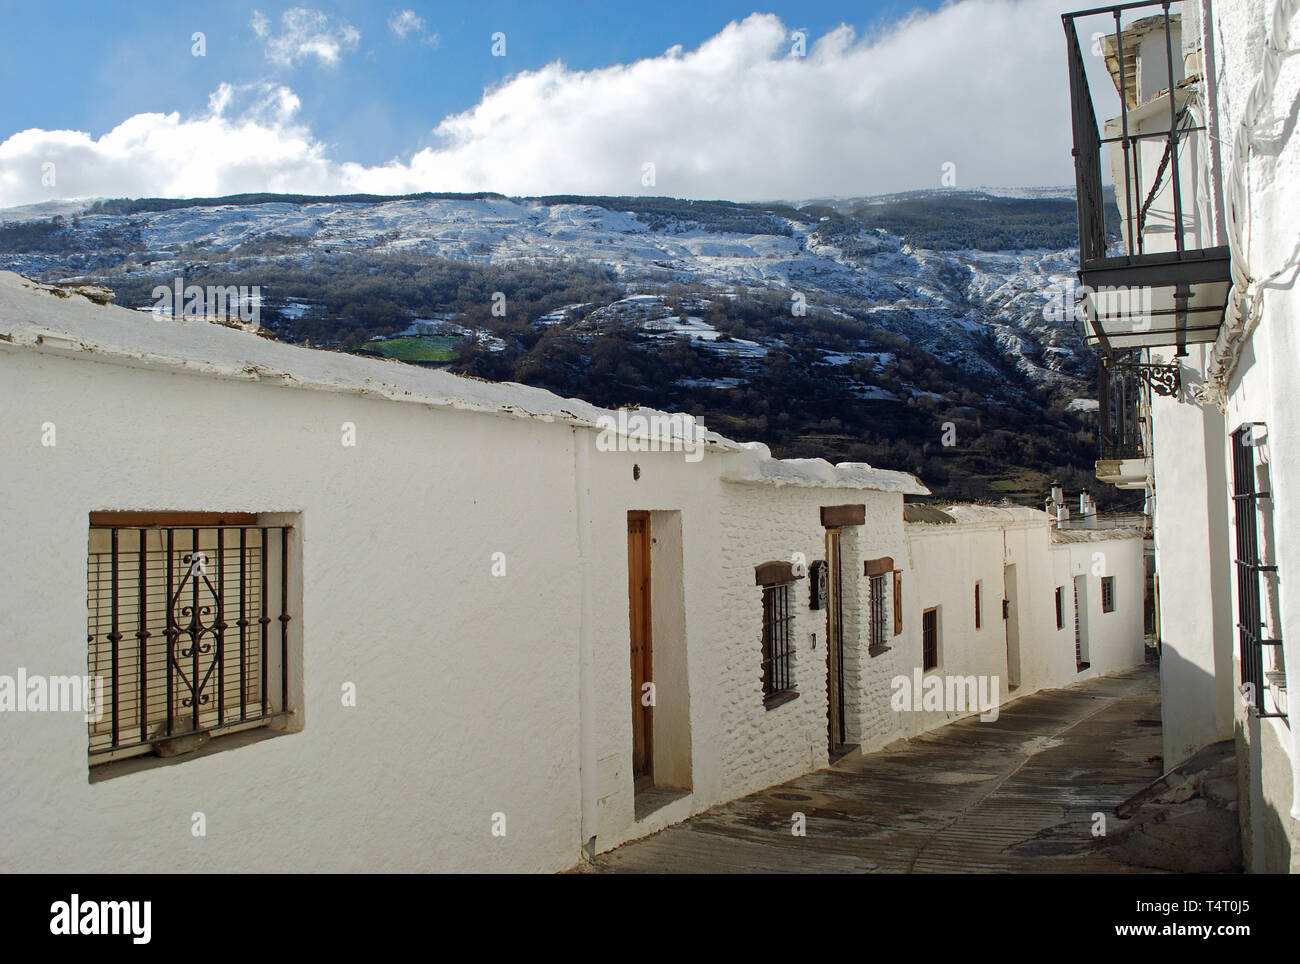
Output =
[{"x1": 0, "y1": 0, "x2": 1104, "y2": 207}]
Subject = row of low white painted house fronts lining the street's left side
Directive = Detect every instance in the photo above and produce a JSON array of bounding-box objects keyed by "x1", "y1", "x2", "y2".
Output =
[{"x1": 0, "y1": 274, "x2": 1141, "y2": 872}]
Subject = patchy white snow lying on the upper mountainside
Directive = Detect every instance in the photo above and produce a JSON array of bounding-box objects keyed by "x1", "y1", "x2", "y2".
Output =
[{"x1": 0, "y1": 188, "x2": 1086, "y2": 400}]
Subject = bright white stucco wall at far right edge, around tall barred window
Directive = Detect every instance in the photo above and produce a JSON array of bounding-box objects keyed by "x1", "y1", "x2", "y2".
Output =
[{"x1": 1208, "y1": 0, "x2": 1300, "y2": 870}]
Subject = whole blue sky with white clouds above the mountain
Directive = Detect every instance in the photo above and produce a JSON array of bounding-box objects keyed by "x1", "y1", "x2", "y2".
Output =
[{"x1": 0, "y1": 0, "x2": 1118, "y2": 207}]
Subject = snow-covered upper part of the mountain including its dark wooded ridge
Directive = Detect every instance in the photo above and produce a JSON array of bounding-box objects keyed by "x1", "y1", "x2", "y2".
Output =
[{"x1": 0, "y1": 190, "x2": 1091, "y2": 400}]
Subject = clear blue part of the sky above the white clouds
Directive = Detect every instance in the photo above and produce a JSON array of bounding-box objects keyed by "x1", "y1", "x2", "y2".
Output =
[{"x1": 0, "y1": 0, "x2": 939, "y2": 164}]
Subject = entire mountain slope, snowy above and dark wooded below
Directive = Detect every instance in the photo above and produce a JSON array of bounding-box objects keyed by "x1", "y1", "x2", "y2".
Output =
[{"x1": 0, "y1": 191, "x2": 1112, "y2": 500}]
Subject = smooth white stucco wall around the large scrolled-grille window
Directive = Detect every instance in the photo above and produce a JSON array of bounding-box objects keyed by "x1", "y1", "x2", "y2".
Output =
[{"x1": 0, "y1": 352, "x2": 582, "y2": 872}]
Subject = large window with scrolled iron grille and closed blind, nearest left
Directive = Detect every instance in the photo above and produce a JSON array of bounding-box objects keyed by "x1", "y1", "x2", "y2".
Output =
[{"x1": 86, "y1": 513, "x2": 291, "y2": 767}]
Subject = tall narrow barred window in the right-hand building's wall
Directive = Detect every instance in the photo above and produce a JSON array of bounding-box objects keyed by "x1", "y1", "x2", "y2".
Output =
[{"x1": 1232, "y1": 425, "x2": 1287, "y2": 718}]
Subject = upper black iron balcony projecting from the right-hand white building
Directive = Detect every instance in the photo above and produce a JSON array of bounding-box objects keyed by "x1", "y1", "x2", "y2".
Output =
[{"x1": 1062, "y1": 0, "x2": 1230, "y2": 355}]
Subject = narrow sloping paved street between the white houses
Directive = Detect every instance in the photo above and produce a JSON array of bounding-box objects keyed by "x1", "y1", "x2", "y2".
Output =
[{"x1": 586, "y1": 665, "x2": 1240, "y2": 873}]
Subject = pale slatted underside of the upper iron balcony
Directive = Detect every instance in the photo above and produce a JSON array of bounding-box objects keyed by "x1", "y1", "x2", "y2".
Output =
[{"x1": 1079, "y1": 247, "x2": 1231, "y2": 353}]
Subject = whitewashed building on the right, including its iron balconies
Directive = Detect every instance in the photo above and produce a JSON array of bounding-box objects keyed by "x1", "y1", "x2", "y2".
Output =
[{"x1": 1065, "y1": 0, "x2": 1300, "y2": 872}]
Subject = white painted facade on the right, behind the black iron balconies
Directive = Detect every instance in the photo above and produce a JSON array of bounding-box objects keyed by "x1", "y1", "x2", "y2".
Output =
[{"x1": 1086, "y1": 0, "x2": 1300, "y2": 872}]
